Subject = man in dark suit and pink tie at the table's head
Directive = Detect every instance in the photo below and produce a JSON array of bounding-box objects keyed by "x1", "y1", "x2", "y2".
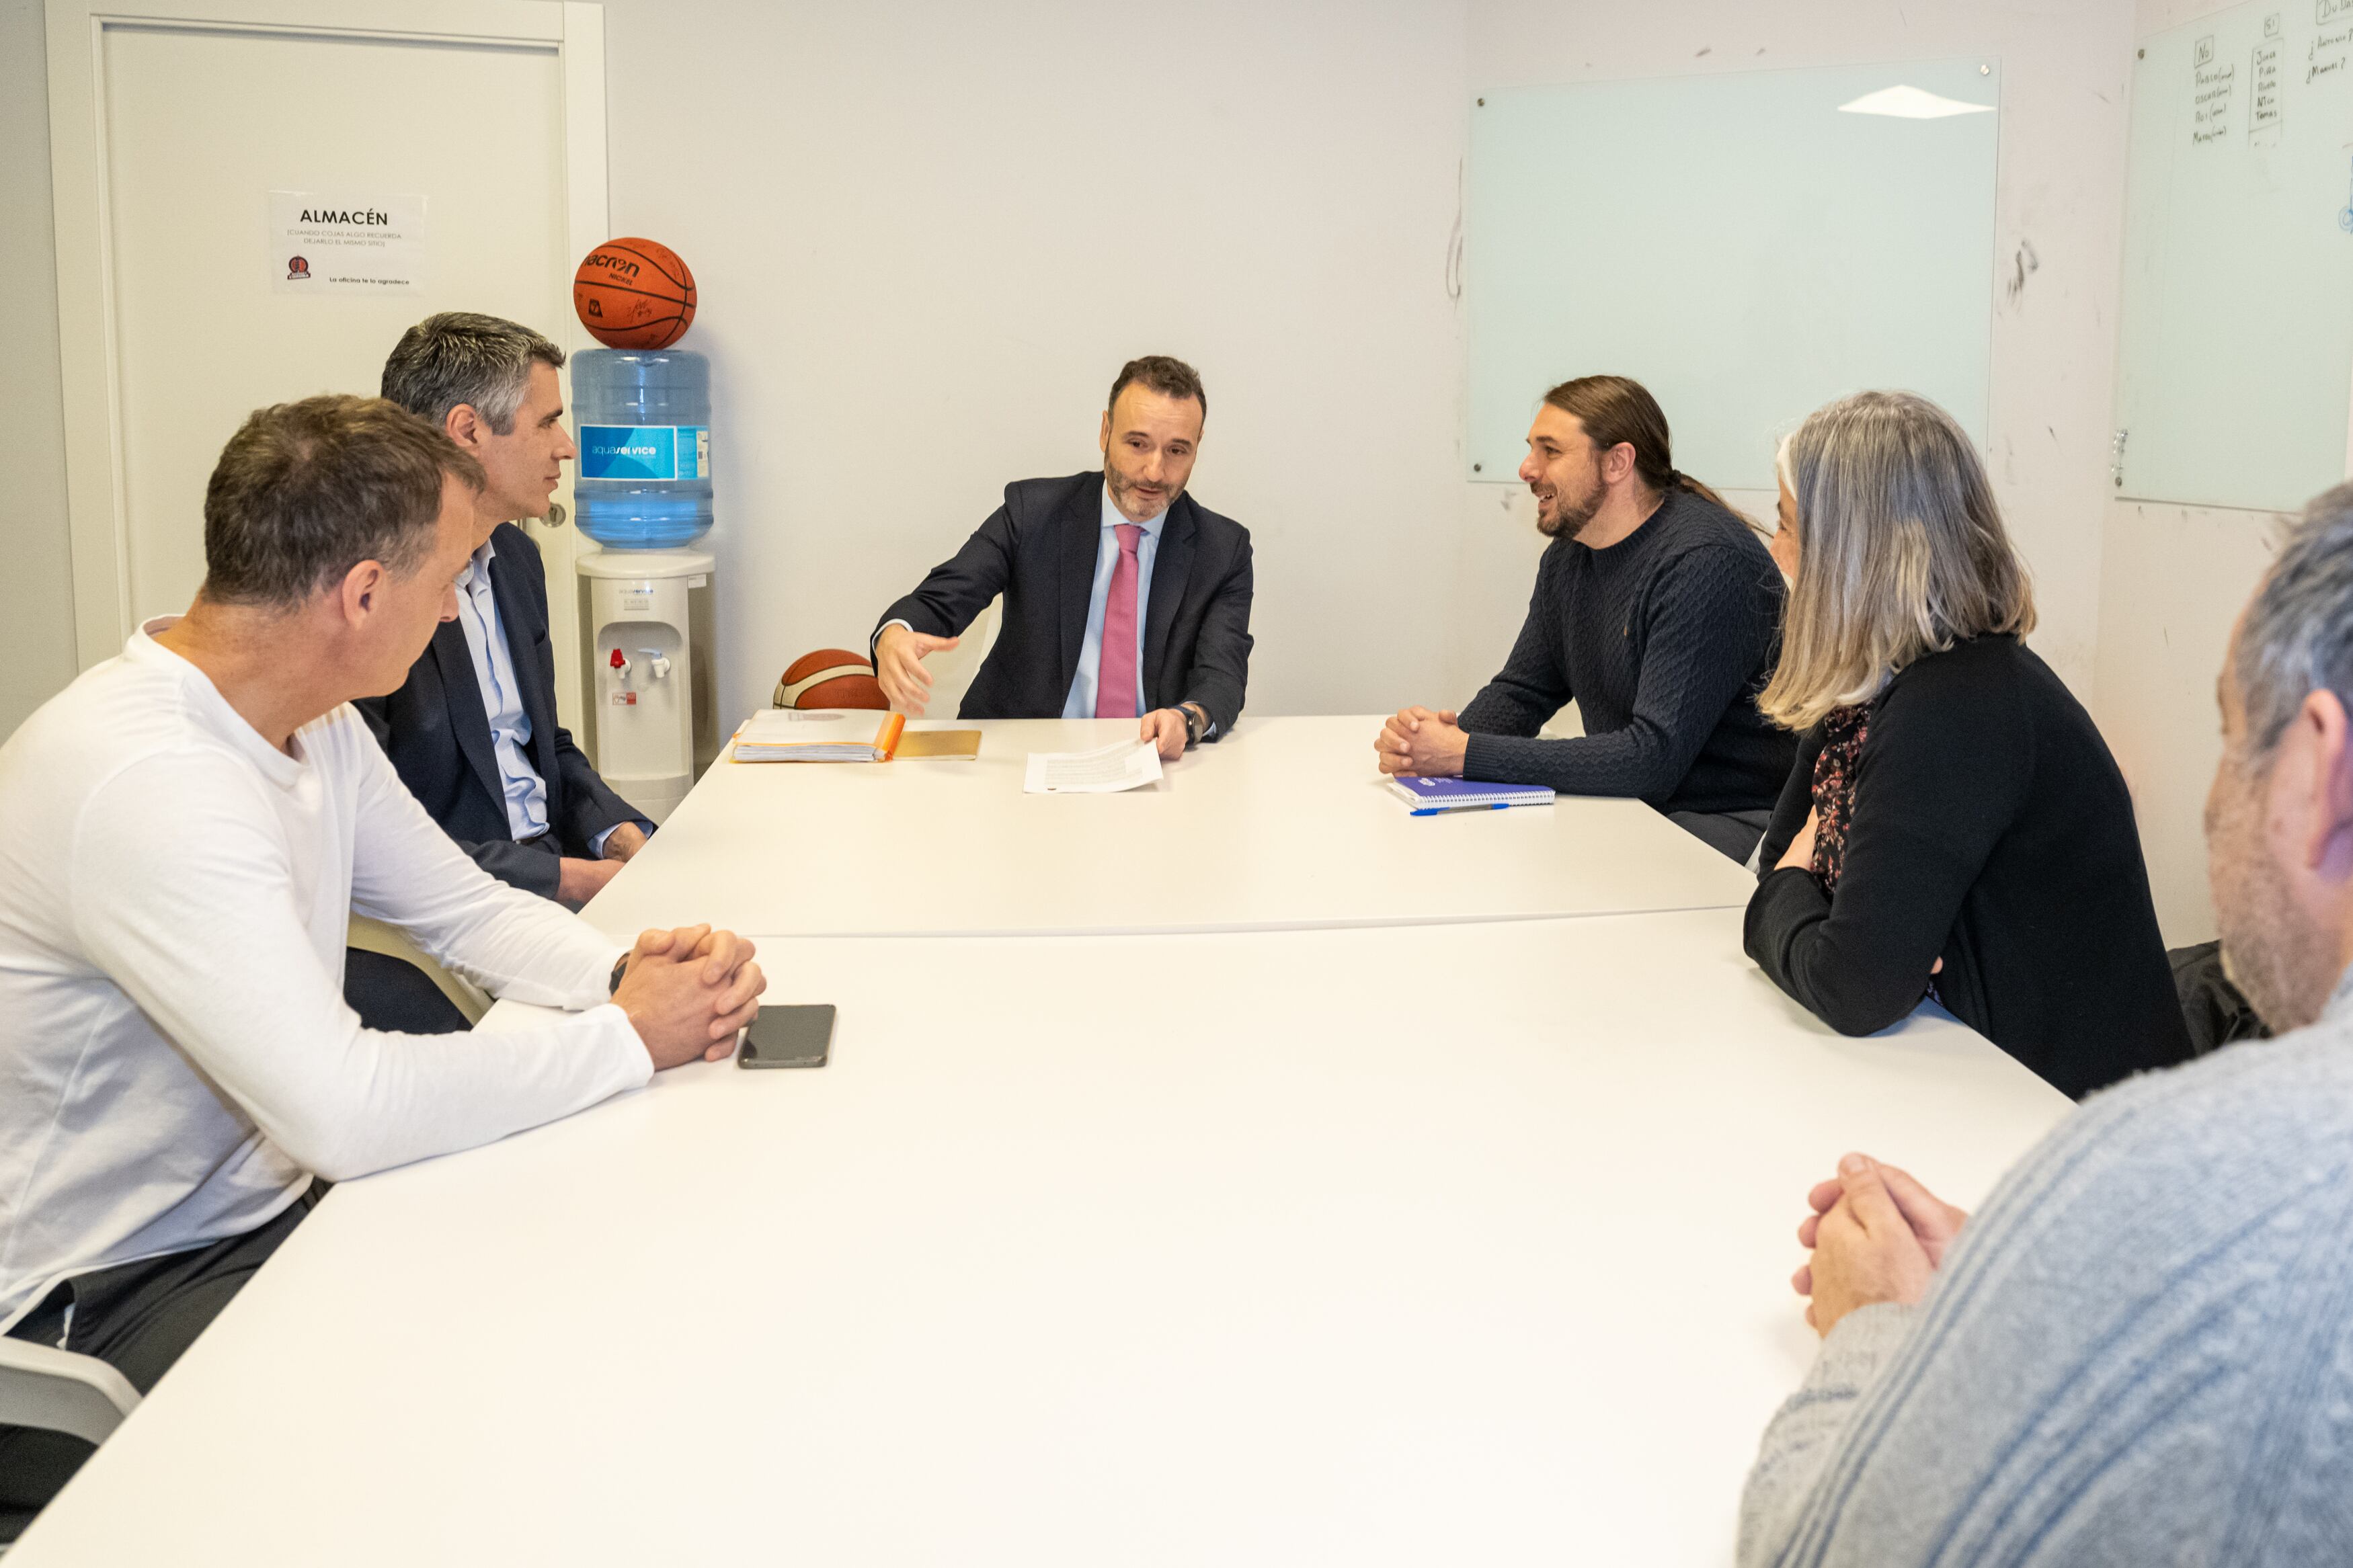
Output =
[{"x1": 873, "y1": 355, "x2": 1252, "y2": 761}]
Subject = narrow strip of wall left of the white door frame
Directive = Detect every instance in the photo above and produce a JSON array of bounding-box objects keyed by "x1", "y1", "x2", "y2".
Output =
[{"x1": 0, "y1": 0, "x2": 75, "y2": 741}]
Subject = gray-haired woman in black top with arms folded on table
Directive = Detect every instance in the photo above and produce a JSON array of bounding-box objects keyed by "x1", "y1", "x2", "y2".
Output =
[{"x1": 1746, "y1": 393, "x2": 2191, "y2": 1098}]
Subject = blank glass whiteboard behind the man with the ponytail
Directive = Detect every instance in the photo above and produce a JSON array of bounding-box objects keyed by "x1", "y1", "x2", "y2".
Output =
[{"x1": 1464, "y1": 58, "x2": 2000, "y2": 489}]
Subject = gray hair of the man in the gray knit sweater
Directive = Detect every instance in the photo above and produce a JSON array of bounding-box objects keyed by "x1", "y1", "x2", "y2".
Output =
[{"x1": 2231, "y1": 485, "x2": 2353, "y2": 764}]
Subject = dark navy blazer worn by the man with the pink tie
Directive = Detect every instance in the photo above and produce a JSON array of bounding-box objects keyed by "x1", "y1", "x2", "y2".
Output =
[{"x1": 875, "y1": 470, "x2": 1252, "y2": 736}]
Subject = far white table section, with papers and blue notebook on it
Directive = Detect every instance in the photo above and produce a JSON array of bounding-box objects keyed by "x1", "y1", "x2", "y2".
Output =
[{"x1": 588, "y1": 712, "x2": 1755, "y2": 940}]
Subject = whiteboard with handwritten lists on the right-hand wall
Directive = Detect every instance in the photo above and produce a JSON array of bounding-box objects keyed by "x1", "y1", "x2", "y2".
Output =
[{"x1": 2111, "y1": 0, "x2": 2353, "y2": 510}]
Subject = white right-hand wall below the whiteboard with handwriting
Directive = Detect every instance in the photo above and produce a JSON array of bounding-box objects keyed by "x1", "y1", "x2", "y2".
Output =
[{"x1": 2097, "y1": 0, "x2": 2280, "y2": 948}]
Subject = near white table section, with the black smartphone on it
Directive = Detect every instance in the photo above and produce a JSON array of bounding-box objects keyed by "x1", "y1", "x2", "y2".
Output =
[{"x1": 9, "y1": 912, "x2": 2066, "y2": 1568}]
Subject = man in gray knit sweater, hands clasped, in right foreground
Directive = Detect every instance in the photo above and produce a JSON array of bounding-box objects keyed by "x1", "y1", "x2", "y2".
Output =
[{"x1": 1739, "y1": 485, "x2": 2353, "y2": 1568}]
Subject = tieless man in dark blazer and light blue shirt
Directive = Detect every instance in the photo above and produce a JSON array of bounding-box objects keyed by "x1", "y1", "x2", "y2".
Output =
[{"x1": 344, "y1": 311, "x2": 652, "y2": 1032}]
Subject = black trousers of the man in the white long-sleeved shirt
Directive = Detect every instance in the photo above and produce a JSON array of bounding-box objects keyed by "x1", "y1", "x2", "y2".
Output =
[{"x1": 0, "y1": 1180, "x2": 327, "y2": 1542}]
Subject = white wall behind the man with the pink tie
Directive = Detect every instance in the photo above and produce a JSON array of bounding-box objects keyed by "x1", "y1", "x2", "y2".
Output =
[{"x1": 605, "y1": 0, "x2": 1466, "y2": 743}]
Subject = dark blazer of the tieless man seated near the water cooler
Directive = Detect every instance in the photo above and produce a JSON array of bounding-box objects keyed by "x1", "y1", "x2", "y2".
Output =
[{"x1": 353, "y1": 522, "x2": 645, "y2": 898}]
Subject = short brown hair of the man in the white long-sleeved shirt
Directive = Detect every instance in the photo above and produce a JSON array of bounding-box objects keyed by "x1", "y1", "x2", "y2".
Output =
[{"x1": 202, "y1": 395, "x2": 483, "y2": 609}]
